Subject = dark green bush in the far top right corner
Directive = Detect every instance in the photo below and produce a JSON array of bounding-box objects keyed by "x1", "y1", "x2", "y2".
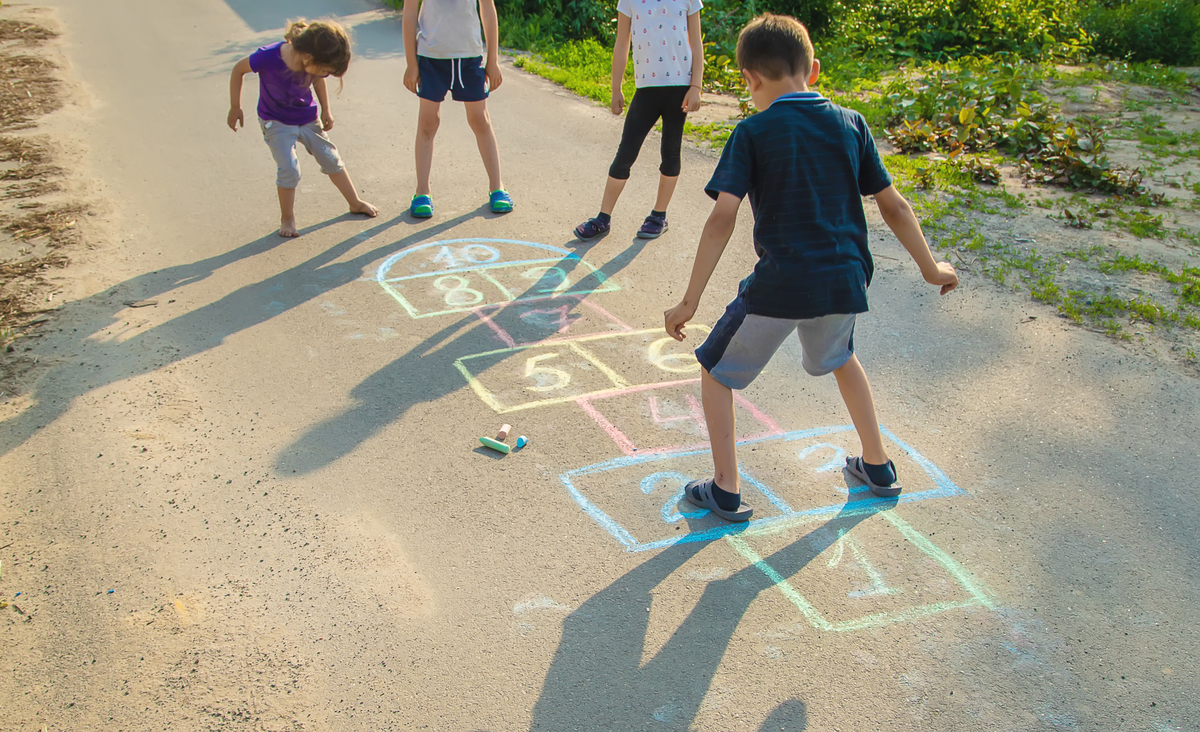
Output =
[{"x1": 1082, "y1": 0, "x2": 1200, "y2": 66}]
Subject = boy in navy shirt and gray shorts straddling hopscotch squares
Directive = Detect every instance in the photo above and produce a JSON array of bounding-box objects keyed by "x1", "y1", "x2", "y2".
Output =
[{"x1": 665, "y1": 13, "x2": 959, "y2": 521}]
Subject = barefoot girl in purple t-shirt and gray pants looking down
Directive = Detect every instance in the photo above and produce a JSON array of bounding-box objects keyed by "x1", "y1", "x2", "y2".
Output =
[{"x1": 227, "y1": 20, "x2": 379, "y2": 236}]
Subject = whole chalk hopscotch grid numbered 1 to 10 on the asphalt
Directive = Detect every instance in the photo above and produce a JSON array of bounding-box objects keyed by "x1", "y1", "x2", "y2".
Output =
[{"x1": 374, "y1": 239, "x2": 994, "y2": 631}]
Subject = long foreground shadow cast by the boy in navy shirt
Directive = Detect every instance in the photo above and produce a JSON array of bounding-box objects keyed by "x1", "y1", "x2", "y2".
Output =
[{"x1": 530, "y1": 499, "x2": 895, "y2": 731}]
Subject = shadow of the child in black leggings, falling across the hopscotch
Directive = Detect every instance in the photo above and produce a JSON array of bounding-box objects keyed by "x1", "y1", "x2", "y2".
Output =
[{"x1": 275, "y1": 239, "x2": 646, "y2": 474}]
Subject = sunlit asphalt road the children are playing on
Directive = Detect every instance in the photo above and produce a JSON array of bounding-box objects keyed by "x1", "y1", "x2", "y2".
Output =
[{"x1": 0, "y1": 0, "x2": 1200, "y2": 732}]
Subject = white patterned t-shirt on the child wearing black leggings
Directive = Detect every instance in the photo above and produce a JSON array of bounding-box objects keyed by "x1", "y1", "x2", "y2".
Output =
[{"x1": 617, "y1": 0, "x2": 703, "y2": 89}]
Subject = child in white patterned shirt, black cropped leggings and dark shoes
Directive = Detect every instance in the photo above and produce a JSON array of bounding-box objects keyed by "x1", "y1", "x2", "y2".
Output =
[{"x1": 575, "y1": 0, "x2": 704, "y2": 239}]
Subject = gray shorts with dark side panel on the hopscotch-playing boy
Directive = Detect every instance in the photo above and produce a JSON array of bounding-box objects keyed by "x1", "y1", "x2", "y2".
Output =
[{"x1": 696, "y1": 298, "x2": 854, "y2": 389}]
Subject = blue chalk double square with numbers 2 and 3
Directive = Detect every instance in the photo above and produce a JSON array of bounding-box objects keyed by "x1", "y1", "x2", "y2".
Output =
[{"x1": 559, "y1": 425, "x2": 966, "y2": 552}]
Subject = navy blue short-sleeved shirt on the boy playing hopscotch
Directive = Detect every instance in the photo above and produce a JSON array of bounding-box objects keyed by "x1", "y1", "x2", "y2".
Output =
[{"x1": 704, "y1": 91, "x2": 892, "y2": 319}]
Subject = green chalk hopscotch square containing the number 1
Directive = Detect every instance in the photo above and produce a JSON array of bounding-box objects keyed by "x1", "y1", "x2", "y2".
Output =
[{"x1": 727, "y1": 510, "x2": 992, "y2": 632}]
